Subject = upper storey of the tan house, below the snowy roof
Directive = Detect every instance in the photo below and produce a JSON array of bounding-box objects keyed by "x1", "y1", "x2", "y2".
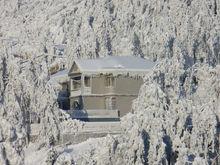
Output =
[{"x1": 70, "y1": 74, "x2": 143, "y2": 97}]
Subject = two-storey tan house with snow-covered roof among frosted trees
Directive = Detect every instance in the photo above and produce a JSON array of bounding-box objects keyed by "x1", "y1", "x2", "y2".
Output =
[{"x1": 68, "y1": 56, "x2": 155, "y2": 118}]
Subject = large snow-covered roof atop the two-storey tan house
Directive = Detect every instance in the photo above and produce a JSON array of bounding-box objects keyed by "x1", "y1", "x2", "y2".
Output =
[{"x1": 72, "y1": 56, "x2": 155, "y2": 73}]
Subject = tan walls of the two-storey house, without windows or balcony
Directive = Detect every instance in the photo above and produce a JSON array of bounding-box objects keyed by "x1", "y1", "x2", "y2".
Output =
[{"x1": 70, "y1": 75, "x2": 143, "y2": 116}]
